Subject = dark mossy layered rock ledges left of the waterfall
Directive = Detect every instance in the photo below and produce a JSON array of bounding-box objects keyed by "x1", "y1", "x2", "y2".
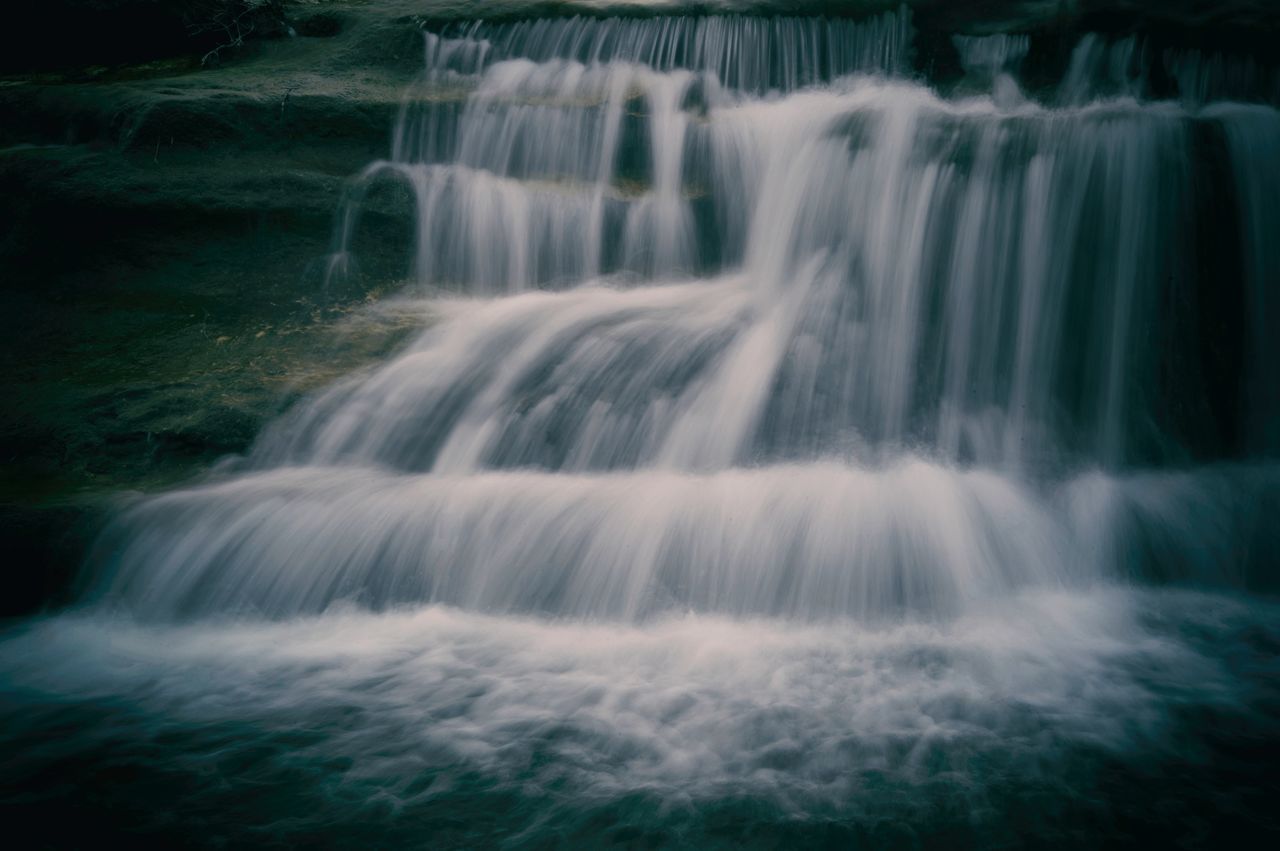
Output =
[{"x1": 0, "y1": 0, "x2": 435, "y2": 617}]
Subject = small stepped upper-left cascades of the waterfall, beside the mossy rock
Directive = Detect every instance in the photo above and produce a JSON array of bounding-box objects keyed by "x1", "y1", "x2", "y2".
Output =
[{"x1": 330, "y1": 10, "x2": 910, "y2": 292}]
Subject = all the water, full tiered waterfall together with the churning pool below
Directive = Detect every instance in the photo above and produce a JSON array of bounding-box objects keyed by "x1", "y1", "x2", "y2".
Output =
[{"x1": 0, "y1": 3, "x2": 1280, "y2": 847}]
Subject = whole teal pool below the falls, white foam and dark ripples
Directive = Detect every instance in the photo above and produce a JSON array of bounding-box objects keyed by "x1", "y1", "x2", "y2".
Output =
[{"x1": 0, "y1": 589, "x2": 1280, "y2": 847}]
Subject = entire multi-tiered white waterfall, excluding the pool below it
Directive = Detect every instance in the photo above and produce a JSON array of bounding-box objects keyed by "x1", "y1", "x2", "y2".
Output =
[{"x1": 82, "y1": 12, "x2": 1280, "y2": 621}]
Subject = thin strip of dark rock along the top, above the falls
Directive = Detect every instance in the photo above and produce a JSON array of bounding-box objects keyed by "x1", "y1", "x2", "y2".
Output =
[{"x1": 10, "y1": 0, "x2": 1280, "y2": 73}]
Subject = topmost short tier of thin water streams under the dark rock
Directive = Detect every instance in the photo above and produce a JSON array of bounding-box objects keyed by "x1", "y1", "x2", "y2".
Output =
[{"x1": 412, "y1": 4, "x2": 1280, "y2": 105}]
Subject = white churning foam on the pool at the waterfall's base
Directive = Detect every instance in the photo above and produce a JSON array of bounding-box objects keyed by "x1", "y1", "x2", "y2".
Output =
[{"x1": 6, "y1": 591, "x2": 1275, "y2": 808}]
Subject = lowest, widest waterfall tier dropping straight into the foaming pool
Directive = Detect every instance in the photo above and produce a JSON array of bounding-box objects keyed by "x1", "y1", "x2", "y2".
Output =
[{"x1": 99, "y1": 459, "x2": 1280, "y2": 621}]
